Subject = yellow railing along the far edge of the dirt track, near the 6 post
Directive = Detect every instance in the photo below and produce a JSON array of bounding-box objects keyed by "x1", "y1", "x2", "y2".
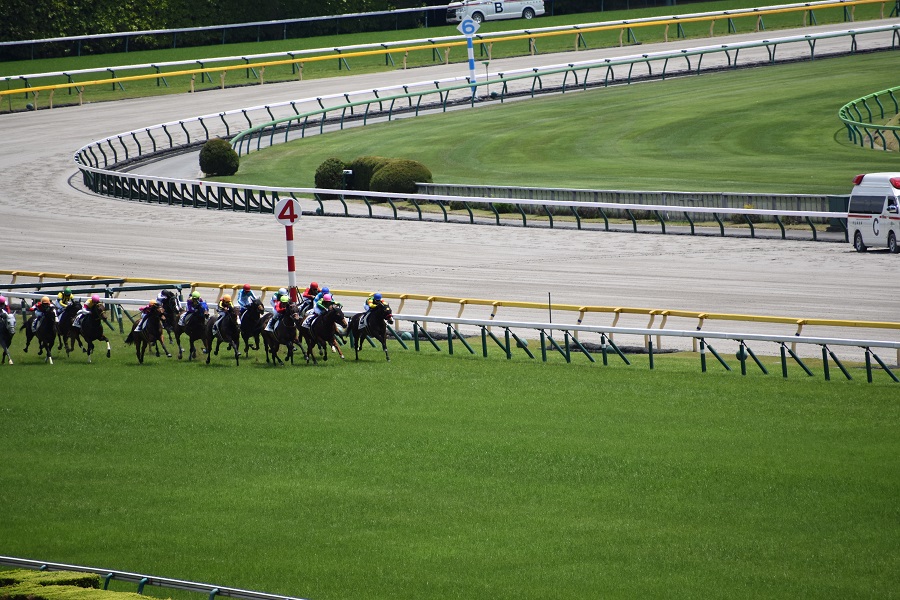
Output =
[{"x1": 0, "y1": 0, "x2": 895, "y2": 102}]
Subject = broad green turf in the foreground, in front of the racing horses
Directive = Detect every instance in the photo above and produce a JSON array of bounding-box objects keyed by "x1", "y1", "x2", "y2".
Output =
[{"x1": 0, "y1": 336, "x2": 900, "y2": 600}]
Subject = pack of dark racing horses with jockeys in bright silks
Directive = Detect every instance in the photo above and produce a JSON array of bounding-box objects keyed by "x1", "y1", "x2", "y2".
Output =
[{"x1": 0, "y1": 294, "x2": 394, "y2": 365}]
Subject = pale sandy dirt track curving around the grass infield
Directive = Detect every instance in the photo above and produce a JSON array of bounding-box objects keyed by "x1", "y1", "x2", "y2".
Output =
[{"x1": 0, "y1": 23, "x2": 900, "y2": 354}]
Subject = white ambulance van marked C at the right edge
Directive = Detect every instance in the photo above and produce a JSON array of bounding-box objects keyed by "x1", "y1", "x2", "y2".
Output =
[{"x1": 847, "y1": 173, "x2": 900, "y2": 254}]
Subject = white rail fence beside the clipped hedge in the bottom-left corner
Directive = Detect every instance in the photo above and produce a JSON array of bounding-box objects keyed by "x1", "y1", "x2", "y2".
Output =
[{"x1": 0, "y1": 556, "x2": 310, "y2": 600}]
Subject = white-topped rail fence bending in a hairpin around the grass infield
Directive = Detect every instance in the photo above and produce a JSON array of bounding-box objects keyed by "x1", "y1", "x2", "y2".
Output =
[{"x1": 67, "y1": 25, "x2": 900, "y2": 240}]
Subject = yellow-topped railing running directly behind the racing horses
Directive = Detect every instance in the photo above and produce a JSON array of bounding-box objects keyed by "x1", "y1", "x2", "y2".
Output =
[{"x1": 0, "y1": 269, "x2": 900, "y2": 363}]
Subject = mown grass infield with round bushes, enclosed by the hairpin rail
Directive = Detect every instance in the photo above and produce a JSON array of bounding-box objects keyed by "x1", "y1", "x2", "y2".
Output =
[{"x1": 220, "y1": 53, "x2": 897, "y2": 194}]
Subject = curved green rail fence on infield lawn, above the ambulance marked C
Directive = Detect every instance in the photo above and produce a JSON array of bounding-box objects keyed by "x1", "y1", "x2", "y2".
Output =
[{"x1": 838, "y1": 86, "x2": 900, "y2": 152}]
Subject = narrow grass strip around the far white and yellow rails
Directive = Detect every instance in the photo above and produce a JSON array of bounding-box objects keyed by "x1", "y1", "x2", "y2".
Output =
[{"x1": 0, "y1": 0, "x2": 890, "y2": 112}]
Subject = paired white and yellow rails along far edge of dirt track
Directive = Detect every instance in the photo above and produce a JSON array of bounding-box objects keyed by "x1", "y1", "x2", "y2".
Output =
[{"x1": 0, "y1": 0, "x2": 896, "y2": 108}]
